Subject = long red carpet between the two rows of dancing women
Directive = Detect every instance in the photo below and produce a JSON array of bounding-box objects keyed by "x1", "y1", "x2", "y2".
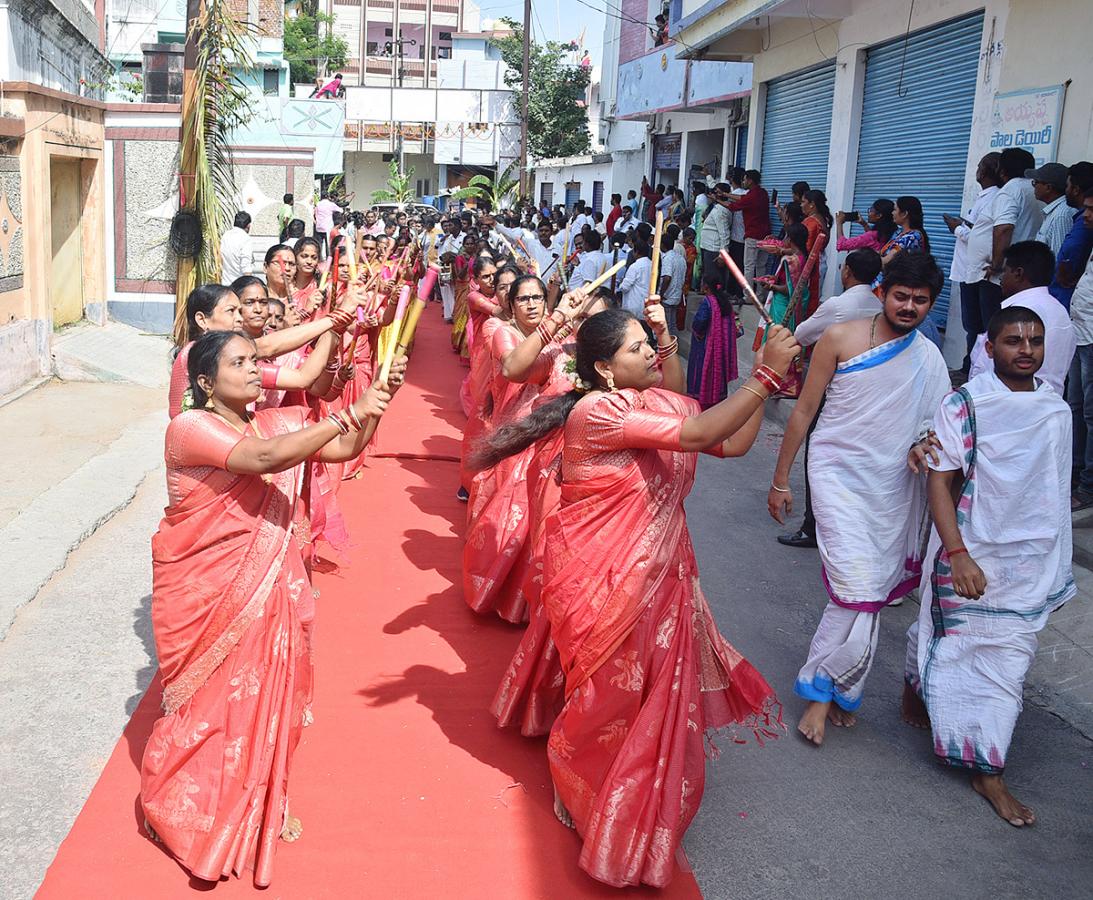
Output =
[{"x1": 38, "y1": 306, "x2": 701, "y2": 900}]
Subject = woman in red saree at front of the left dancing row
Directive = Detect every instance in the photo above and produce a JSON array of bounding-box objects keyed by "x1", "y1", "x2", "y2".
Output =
[{"x1": 141, "y1": 331, "x2": 404, "y2": 887}]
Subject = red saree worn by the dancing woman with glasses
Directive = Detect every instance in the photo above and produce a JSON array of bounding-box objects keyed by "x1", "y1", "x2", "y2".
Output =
[{"x1": 463, "y1": 325, "x2": 557, "y2": 623}]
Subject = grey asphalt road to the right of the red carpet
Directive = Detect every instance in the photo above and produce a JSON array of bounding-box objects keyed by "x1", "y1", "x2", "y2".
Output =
[{"x1": 684, "y1": 424, "x2": 1093, "y2": 900}]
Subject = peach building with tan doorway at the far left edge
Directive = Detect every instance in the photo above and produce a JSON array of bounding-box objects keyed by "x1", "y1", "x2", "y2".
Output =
[{"x1": 0, "y1": 0, "x2": 109, "y2": 396}]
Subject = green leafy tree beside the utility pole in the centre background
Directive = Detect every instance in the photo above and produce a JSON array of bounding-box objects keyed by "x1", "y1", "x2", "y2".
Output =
[{"x1": 492, "y1": 19, "x2": 592, "y2": 159}]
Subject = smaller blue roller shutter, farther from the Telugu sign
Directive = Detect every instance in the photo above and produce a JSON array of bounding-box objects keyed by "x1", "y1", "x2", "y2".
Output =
[{"x1": 755, "y1": 61, "x2": 835, "y2": 204}]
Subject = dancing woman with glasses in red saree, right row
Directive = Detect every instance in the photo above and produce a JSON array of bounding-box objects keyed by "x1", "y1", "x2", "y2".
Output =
[{"x1": 463, "y1": 274, "x2": 562, "y2": 623}]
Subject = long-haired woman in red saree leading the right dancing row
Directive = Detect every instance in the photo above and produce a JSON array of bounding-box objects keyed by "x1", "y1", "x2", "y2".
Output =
[{"x1": 474, "y1": 309, "x2": 798, "y2": 887}]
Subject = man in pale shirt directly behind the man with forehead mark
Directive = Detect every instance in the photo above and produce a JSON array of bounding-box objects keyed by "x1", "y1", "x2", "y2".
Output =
[{"x1": 968, "y1": 241, "x2": 1078, "y2": 397}]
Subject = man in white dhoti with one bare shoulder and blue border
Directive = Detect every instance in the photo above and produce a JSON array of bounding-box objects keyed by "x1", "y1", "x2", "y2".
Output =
[{"x1": 767, "y1": 253, "x2": 950, "y2": 745}]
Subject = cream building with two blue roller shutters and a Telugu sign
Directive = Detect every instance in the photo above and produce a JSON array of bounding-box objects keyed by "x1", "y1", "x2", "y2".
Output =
[{"x1": 671, "y1": 0, "x2": 1093, "y2": 361}]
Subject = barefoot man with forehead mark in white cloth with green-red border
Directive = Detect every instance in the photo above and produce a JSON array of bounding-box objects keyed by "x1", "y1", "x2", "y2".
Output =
[{"x1": 904, "y1": 306, "x2": 1074, "y2": 827}]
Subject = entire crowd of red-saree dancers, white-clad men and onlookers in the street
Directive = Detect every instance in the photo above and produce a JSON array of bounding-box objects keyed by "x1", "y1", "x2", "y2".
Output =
[{"x1": 134, "y1": 151, "x2": 1093, "y2": 886}]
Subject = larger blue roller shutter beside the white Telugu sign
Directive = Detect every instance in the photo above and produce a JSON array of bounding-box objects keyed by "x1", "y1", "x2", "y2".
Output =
[{"x1": 854, "y1": 12, "x2": 983, "y2": 328}]
